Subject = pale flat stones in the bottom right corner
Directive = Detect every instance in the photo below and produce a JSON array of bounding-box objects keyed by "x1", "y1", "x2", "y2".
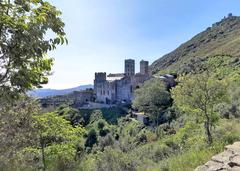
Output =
[{"x1": 195, "y1": 142, "x2": 240, "y2": 171}]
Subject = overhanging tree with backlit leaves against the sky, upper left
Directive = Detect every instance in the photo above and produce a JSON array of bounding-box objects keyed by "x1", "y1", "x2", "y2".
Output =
[{"x1": 0, "y1": 0, "x2": 67, "y2": 97}]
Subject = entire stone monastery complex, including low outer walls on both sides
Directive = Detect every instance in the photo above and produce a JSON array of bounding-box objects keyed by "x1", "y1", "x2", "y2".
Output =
[{"x1": 40, "y1": 59, "x2": 176, "y2": 109}]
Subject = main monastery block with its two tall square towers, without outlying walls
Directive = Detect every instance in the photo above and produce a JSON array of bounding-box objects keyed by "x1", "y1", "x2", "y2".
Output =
[{"x1": 94, "y1": 59, "x2": 150, "y2": 104}]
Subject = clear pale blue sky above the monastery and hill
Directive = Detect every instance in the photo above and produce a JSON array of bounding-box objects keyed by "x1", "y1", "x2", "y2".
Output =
[{"x1": 44, "y1": 0, "x2": 240, "y2": 89}]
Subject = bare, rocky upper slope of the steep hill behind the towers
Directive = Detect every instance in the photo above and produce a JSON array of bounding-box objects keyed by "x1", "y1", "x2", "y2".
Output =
[{"x1": 151, "y1": 14, "x2": 240, "y2": 73}]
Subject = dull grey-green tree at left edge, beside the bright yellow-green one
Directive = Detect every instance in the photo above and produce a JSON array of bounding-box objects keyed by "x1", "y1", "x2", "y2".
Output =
[{"x1": 0, "y1": 96, "x2": 40, "y2": 170}]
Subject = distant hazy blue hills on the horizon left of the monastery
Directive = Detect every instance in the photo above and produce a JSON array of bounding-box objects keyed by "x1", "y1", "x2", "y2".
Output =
[{"x1": 28, "y1": 85, "x2": 93, "y2": 98}]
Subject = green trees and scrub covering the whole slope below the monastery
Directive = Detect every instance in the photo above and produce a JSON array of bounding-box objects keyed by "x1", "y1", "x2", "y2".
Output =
[{"x1": 0, "y1": 55, "x2": 240, "y2": 171}]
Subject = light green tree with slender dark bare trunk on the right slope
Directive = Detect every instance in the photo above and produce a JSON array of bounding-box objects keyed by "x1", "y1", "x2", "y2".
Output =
[{"x1": 171, "y1": 72, "x2": 227, "y2": 144}]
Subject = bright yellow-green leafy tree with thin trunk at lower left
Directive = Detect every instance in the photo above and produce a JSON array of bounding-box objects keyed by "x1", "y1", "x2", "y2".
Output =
[{"x1": 35, "y1": 113, "x2": 85, "y2": 170}]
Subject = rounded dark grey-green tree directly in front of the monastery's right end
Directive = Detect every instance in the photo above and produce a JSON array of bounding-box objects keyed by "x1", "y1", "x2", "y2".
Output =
[{"x1": 133, "y1": 79, "x2": 172, "y2": 125}]
